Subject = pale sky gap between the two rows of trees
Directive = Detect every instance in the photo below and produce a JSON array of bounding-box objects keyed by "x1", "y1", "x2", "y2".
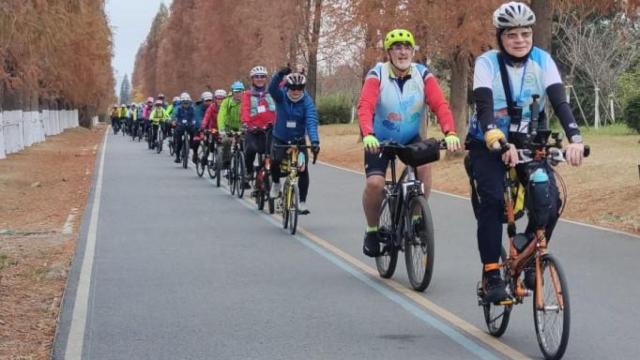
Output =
[{"x1": 105, "y1": 0, "x2": 172, "y2": 93}]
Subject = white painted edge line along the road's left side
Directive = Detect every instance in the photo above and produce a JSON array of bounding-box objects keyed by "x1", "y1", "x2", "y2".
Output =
[{"x1": 64, "y1": 126, "x2": 110, "y2": 360}]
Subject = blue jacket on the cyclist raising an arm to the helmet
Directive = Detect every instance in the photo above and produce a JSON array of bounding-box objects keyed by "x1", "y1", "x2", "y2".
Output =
[{"x1": 269, "y1": 73, "x2": 320, "y2": 144}]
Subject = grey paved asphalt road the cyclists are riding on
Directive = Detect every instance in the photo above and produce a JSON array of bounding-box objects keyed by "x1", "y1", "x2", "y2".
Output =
[{"x1": 54, "y1": 135, "x2": 640, "y2": 359}]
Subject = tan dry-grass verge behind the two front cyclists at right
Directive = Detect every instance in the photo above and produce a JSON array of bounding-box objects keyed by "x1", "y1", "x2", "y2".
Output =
[{"x1": 320, "y1": 125, "x2": 640, "y2": 234}]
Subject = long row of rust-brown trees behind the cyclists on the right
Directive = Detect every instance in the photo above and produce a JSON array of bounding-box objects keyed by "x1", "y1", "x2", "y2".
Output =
[{"x1": 133, "y1": 0, "x2": 638, "y2": 134}]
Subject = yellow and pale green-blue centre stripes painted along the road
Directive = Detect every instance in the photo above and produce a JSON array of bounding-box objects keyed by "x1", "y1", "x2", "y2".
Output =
[{"x1": 209, "y1": 179, "x2": 529, "y2": 360}]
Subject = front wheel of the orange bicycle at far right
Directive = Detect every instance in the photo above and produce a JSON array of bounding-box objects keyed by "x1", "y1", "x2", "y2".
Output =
[{"x1": 533, "y1": 254, "x2": 571, "y2": 359}]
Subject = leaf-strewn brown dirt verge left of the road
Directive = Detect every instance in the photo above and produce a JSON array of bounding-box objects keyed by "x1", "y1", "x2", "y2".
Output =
[{"x1": 0, "y1": 126, "x2": 105, "y2": 359}]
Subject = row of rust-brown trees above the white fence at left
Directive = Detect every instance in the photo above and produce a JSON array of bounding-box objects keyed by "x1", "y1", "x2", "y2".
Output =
[{"x1": 0, "y1": 0, "x2": 115, "y2": 122}]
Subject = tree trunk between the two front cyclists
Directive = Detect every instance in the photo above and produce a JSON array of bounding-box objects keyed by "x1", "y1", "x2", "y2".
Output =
[{"x1": 450, "y1": 51, "x2": 470, "y2": 139}]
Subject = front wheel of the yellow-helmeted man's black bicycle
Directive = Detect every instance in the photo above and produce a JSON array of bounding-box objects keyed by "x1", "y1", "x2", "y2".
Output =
[{"x1": 404, "y1": 196, "x2": 434, "y2": 291}]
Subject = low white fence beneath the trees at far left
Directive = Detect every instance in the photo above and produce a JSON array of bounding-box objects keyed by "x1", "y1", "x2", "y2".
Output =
[{"x1": 0, "y1": 110, "x2": 79, "y2": 159}]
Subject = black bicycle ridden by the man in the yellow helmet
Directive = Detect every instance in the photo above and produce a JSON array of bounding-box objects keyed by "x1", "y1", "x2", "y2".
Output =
[{"x1": 376, "y1": 139, "x2": 446, "y2": 291}]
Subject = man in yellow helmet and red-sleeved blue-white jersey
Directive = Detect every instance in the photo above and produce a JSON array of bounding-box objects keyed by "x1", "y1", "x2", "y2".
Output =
[{"x1": 358, "y1": 29, "x2": 461, "y2": 257}]
